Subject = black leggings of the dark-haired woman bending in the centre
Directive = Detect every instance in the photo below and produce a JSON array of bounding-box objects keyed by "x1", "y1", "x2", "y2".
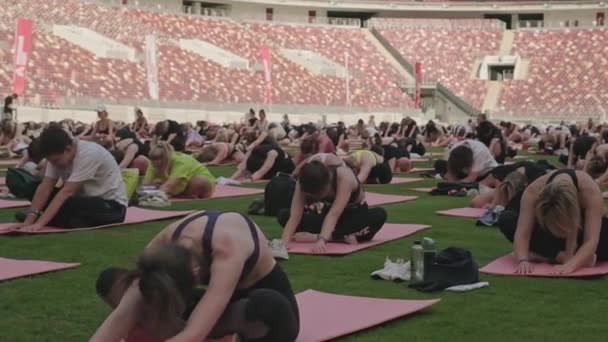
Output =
[{"x1": 277, "y1": 203, "x2": 387, "y2": 242}]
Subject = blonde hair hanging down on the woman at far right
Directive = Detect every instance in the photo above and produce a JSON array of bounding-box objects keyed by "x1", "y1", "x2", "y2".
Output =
[{"x1": 535, "y1": 179, "x2": 581, "y2": 239}]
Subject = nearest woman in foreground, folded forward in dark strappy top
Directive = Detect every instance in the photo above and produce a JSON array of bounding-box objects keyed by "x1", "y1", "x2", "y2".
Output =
[{"x1": 91, "y1": 211, "x2": 300, "y2": 342}]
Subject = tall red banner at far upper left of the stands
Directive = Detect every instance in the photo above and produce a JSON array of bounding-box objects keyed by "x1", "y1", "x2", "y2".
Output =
[{"x1": 13, "y1": 18, "x2": 34, "y2": 95}]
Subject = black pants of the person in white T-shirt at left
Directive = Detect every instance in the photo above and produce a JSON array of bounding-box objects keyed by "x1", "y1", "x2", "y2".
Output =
[{"x1": 37, "y1": 189, "x2": 127, "y2": 229}]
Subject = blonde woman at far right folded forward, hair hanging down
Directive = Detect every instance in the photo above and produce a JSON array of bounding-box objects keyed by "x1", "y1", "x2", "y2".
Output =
[{"x1": 498, "y1": 169, "x2": 608, "y2": 274}]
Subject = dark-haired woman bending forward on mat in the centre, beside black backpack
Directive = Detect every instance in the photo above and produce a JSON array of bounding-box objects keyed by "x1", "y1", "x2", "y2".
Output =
[{"x1": 271, "y1": 154, "x2": 386, "y2": 259}]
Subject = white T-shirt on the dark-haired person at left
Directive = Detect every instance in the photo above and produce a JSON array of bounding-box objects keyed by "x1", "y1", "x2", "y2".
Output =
[{"x1": 46, "y1": 140, "x2": 128, "y2": 206}]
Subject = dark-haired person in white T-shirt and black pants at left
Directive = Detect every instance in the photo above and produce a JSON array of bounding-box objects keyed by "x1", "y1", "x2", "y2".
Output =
[{"x1": 13, "y1": 126, "x2": 127, "y2": 232}]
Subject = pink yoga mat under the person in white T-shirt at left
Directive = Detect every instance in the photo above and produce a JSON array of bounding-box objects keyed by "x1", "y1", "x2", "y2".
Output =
[{"x1": 0, "y1": 207, "x2": 193, "y2": 235}]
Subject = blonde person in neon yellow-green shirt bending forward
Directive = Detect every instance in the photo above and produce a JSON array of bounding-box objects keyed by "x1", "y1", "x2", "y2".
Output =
[{"x1": 144, "y1": 142, "x2": 215, "y2": 198}]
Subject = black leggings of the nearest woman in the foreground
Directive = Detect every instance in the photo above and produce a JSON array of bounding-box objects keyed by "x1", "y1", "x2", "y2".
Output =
[{"x1": 96, "y1": 264, "x2": 300, "y2": 342}]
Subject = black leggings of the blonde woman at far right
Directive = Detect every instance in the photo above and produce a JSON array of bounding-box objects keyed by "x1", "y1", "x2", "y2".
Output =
[{"x1": 496, "y1": 210, "x2": 608, "y2": 261}]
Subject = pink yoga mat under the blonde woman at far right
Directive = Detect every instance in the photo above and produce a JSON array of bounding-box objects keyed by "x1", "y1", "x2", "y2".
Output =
[{"x1": 480, "y1": 255, "x2": 608, "y2": 278}]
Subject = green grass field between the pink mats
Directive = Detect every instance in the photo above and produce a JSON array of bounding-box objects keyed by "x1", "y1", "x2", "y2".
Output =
[{"x1": 0, "y1": 153, "x2": 608, "y2": 342}]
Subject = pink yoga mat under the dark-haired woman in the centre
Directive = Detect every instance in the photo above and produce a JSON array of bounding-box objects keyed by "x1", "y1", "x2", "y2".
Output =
[{"x1": 289, "y1": 223, "x2": 431, "y2": 255}]
